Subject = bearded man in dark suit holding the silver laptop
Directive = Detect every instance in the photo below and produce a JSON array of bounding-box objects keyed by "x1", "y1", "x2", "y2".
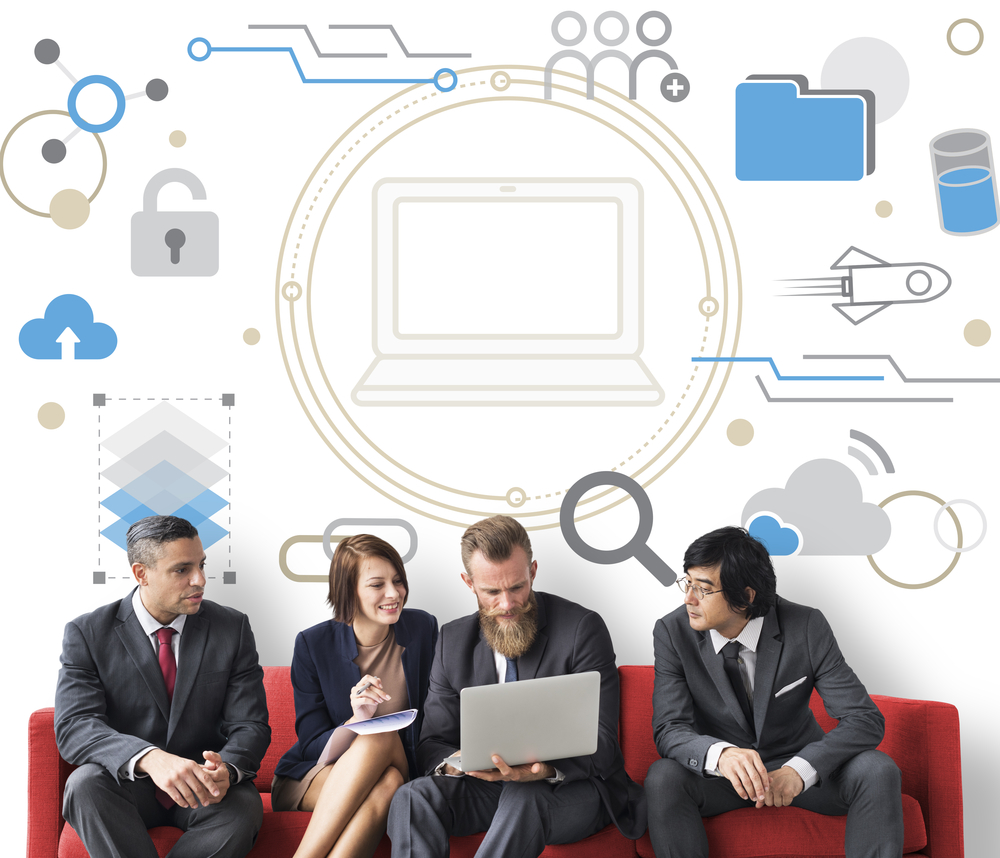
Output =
[{"x1": 388, "y1": 515, "x2": 646, "y2": 858}]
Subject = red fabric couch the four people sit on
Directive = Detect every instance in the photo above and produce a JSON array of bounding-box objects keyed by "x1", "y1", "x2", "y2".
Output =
[{"x1": 28, "y1": 666, "x2": 965, "y2": 858}]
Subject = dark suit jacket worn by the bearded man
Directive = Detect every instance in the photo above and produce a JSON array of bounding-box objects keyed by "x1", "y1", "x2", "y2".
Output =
[{"x1": 417, "y1": 592, "x2": 646, "y2": 840}]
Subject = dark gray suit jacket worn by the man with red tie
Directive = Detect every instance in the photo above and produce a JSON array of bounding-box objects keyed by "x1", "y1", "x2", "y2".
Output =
[{"x1": 55, "y1": 593, "x2": 271, "y2": 780}]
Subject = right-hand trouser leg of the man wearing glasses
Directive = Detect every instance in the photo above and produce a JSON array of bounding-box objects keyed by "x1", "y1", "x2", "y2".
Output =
[{"x1": 792, "y1": 751, "x2": 903, "y2": 858}]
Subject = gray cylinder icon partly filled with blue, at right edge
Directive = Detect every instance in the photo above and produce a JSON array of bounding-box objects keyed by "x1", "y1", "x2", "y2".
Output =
[{"x1": 931, "y1": 128, "x2": 1000, "y2": 235}]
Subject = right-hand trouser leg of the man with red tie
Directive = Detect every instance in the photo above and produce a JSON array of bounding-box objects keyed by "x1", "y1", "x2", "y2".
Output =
[{"x1": 168, "y1": 781, "x2": 264, "y2": 858}]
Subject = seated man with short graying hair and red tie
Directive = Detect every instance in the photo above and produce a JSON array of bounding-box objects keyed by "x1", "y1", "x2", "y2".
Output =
[{"x1": 55, "y1": 515, "x2": 271, "y2": 858}]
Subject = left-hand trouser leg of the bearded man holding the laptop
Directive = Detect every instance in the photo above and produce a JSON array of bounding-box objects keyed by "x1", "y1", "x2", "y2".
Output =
[{"x1": 387, "y1": 776, "x2": 501, "y2": 858}]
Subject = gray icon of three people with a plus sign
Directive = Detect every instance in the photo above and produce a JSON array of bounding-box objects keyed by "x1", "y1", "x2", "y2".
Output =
[{"x1": 545, "y1": 10, "x2": 691, "y2": 102}]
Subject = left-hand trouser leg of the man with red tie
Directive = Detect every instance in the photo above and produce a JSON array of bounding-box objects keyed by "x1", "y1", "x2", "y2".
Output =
[{"x1": 63, "y1": 763, "x2": 168, "y2": 858}]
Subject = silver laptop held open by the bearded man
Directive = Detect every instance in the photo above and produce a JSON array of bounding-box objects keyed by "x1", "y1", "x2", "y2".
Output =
[{"x1": 447, "y1": 670, "x2": 601, "y2": 772}]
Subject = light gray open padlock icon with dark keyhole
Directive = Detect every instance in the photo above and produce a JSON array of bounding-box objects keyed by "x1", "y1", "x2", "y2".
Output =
[{"x1": 132, "y1": 167, "x2": 219, "y2": 277}]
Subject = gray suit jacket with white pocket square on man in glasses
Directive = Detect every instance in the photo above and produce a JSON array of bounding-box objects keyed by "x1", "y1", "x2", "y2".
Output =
[{"x1": 653, "y1": 596, "x2": 885, "y2": 779}]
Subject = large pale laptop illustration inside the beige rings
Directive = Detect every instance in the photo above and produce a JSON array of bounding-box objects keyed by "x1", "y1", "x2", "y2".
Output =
[{"x1": 351, "y1": 178, "x2": 664, "y2": 406}]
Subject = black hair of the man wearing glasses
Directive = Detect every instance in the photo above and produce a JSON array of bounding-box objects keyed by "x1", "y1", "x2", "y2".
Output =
[{"x1": 684, "y1": 527, "x2": 777, "y2": 620}]
